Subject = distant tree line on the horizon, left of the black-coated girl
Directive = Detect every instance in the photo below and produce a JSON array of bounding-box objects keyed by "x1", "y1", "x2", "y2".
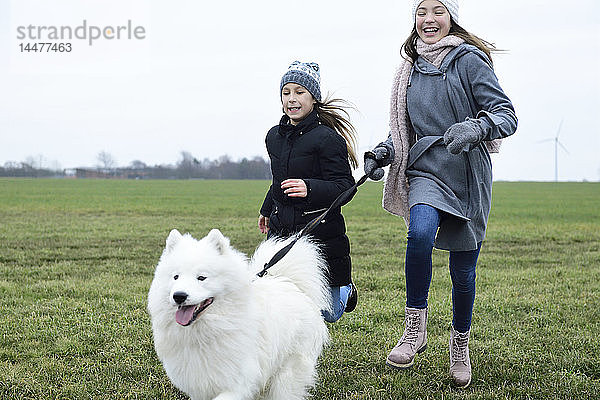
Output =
[{"x1": 0, "y1": 151, "x2": 271, "y2": 179}]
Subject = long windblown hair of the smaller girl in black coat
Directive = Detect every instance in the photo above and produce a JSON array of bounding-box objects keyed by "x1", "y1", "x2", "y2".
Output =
[{"x1": 314, "y1": 95, "x2": 358, "y2": 169}]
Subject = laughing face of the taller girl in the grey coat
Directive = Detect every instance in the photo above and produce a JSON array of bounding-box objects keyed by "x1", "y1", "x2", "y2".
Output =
[{"x1": 415, "y1": 0, "x2": 451, "y2": 44}]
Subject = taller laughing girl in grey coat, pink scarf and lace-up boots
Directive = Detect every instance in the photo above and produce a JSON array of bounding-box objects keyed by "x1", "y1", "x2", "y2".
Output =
[{"x1": 365, "y1": 0, "x2": 517, "y2": 387}]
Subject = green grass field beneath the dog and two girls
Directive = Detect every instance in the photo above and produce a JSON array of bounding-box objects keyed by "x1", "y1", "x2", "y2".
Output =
[{"x1": 0, "y1": 179, "x2": 600, "y2": 400}]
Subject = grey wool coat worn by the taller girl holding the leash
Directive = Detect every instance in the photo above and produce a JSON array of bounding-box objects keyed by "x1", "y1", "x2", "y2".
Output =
[{"x1": 385, "y1": 43, "x2": 517, "y2": 251}]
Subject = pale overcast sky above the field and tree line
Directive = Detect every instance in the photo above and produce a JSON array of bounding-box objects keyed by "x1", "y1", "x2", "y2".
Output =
[{"x1": 0, "y1": 0, "x2": 600, "y2": 181}]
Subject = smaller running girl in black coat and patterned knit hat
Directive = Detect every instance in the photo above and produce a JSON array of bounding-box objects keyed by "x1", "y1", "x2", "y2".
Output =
[{"x1": 258, "y1": 61, "x2": 357, "y2": 322}]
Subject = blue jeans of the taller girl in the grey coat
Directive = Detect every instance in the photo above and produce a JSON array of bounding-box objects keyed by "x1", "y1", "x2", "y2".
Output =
[{"x1": 405, "y1": 204, "x2": 481, "y2": 332}]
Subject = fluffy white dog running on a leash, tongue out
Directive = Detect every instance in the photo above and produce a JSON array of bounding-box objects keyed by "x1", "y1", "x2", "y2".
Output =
[{"x1": 148, "y1": 229, "x2": 331, "y2": 400}]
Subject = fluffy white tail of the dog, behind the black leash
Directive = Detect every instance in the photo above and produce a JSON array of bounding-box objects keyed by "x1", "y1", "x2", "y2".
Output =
[{"x1": 250, "y1": 237, "x2": 331, "y2": 311}]
